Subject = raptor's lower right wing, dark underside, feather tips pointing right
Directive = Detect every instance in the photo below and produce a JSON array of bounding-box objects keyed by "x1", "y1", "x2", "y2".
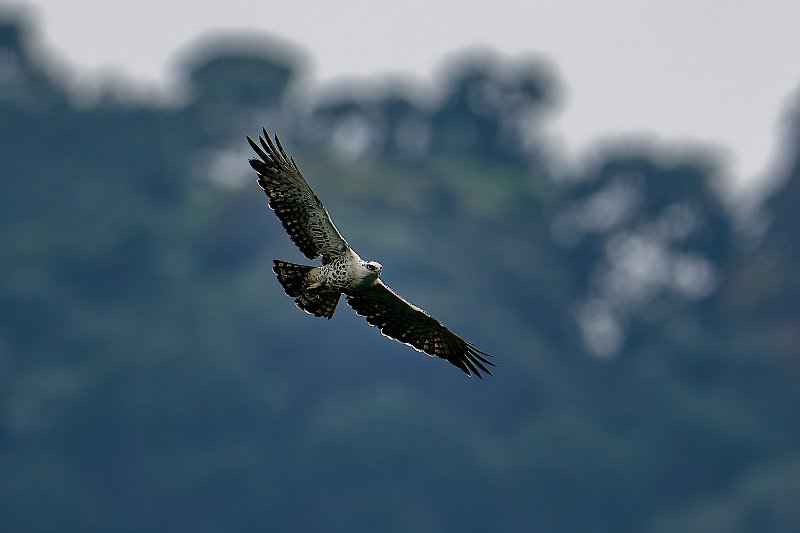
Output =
[{"x1": 347, "y1": 279, "x2": 496, "y2": 379}]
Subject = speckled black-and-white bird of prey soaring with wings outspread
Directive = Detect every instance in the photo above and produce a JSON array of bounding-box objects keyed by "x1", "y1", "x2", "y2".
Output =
[{"x1": 247, "y1": 130, "x2": 495, "y2": 378}]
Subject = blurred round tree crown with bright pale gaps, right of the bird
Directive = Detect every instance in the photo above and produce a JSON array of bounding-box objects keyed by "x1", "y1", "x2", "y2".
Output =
[{"x1": 553, "y1": 148, "x2": 735, "y2": 356}]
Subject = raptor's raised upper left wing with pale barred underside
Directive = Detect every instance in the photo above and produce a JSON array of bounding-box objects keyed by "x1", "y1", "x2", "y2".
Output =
[{"x1": 247, "y1": 130, "x2": 349, "y2": 263}]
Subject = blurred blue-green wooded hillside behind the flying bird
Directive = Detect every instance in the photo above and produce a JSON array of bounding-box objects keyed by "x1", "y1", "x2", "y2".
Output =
[{"x1": 0, "y1": 2, "x2": 800, "y2": 533}]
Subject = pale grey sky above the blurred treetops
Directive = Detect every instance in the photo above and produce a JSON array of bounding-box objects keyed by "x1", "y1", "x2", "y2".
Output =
[{"x1": 10, "y1": 0, "x2": 800, "y2": 191}]
